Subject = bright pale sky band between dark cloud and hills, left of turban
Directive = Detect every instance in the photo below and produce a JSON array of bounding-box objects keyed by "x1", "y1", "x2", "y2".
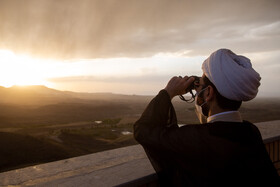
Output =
[{"x1": 0, "y1": 50, "x2": 205, "y2": 94}]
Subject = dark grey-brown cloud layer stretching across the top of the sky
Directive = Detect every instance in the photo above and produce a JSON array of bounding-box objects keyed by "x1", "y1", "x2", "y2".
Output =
[{"x1": 0, "y1": 0, "x2": 280, "y2": 59}]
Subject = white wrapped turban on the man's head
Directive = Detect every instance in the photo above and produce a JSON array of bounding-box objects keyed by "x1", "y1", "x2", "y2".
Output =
[{"x1": 202, "y1": 49, "x2": 261, "y2": 101}]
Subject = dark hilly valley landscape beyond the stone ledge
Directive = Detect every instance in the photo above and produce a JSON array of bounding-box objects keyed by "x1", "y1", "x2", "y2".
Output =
[{"x1": 0, "y1": 86, "x2": 280, "y2": 171}]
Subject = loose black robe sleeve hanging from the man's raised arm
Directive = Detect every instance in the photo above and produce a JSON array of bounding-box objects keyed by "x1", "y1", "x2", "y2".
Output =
[{"x1": 134, "y1": 90, "x2": 179, "y2": 186}]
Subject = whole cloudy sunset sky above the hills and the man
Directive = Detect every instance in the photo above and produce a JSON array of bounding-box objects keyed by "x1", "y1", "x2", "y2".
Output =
[{"x1": 0, "y1": 0, "x2": 280, "y2": 97}]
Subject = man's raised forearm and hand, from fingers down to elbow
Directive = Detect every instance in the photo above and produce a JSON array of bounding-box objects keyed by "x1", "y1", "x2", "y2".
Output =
[{"x1": 134, "y1": 76, "x2": 194, "y2": 147}]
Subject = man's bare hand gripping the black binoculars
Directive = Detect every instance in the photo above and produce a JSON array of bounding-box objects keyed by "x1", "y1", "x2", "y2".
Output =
[{"x1": 164, "y1": 76, "x2": 195, "y2": 99}]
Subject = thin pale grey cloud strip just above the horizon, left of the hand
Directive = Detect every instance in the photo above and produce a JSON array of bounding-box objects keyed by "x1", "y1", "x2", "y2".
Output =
[{"x1": 48, "y1": 75, "x2": 170, "y2": 95}]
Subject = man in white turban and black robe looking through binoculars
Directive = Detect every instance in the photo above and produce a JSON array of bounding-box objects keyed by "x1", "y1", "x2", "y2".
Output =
[{"x1": 134, "y1": 49, "x2": 280, "y2": 186}]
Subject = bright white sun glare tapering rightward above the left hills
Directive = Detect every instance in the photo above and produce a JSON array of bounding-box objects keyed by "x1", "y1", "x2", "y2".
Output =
[{"x1": 0, "y1": 50, "x2": 87, "y2": 87}]
